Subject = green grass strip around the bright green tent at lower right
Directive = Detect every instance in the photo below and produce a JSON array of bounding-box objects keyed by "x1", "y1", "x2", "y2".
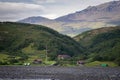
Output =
[{"x1": 85, "y1": 61, "x2": 118, "y2": 67}]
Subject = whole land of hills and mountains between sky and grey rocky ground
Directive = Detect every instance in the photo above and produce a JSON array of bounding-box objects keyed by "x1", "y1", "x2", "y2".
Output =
[{"x1": 0, "y1": 1, "x2": 120, "y2": 67}]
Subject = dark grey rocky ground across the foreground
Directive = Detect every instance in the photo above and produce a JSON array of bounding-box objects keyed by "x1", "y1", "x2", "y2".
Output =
[{"x1": 0, "y1": 66, "x2": 120, "y2": 80}]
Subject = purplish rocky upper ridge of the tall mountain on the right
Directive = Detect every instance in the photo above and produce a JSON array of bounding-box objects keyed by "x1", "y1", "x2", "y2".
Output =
[{"x1": 56, "y1": 1, "x2": 120, "y2": 21}]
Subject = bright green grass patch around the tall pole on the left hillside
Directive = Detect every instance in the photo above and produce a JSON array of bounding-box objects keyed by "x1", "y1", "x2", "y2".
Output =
[{"x1": 22, "y1": 43, "x2": 56, "y2": 65}]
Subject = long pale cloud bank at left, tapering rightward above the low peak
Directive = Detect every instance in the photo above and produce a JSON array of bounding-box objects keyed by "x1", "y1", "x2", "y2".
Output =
[{"x1": 0, "y1": 2, "x2": 45, "y2": 20}]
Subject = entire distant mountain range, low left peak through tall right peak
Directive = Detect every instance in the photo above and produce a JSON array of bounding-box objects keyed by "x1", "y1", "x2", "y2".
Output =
[{"x1": 18, "y1": 1, "x2": 120, "y2": 36}]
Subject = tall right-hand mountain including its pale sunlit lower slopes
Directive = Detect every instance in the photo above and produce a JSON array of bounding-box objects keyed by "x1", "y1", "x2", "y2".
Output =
[{"x1": 55, "y1": 1, "x2": 120, "y2": 34}]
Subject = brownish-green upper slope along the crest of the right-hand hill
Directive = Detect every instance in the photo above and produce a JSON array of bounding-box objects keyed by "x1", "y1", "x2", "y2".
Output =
[{"x1": 74, "y1": 26, "x2": 120, "y2": 47}]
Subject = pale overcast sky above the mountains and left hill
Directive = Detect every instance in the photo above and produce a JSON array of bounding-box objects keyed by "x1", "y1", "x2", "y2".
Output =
[{"x1": 0, "y1": 0, "x2": 117, "y2": 21}]
